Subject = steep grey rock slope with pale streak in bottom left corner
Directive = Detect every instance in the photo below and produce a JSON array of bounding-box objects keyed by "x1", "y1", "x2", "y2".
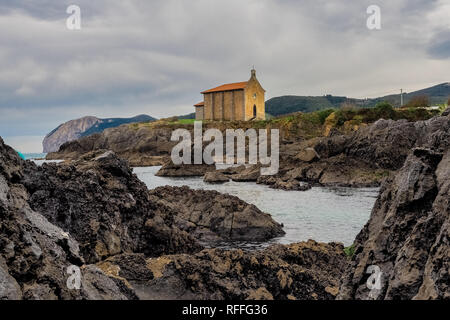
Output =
[{"x1": 0, "y1": 138, "x2": 137, "y2": 300}]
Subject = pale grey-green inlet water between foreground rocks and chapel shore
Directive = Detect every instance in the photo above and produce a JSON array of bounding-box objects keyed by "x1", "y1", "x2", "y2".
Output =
[{"x1": 134, "y1": 167, "x2": 379, "y2": 248}]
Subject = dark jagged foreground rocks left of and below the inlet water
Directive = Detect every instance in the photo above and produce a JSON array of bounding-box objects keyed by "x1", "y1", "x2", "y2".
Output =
[{"x1": 0, "y1": 140, "x2": 346, "y2": 299}]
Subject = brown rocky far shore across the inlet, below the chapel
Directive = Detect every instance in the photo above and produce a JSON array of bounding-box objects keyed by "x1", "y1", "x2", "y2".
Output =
[{"x1": 47, "y1": 112, "x2": 450, "y2": 190}]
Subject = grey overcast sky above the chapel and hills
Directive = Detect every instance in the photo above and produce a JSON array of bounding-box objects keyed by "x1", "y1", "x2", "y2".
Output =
[{"x1": 0, "y1": 0, "x2": 450, "y2": 152}]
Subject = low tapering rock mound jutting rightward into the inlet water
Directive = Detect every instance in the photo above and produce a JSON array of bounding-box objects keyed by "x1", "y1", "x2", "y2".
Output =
[{"x1": 150, "y1": 186, "x2": 284, "y2": 242}]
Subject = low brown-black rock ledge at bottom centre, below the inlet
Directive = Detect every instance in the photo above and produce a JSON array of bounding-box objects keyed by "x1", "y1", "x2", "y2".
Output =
[{"x1": 93, "y1": 240, "x2": 347, "y2": 300}]
